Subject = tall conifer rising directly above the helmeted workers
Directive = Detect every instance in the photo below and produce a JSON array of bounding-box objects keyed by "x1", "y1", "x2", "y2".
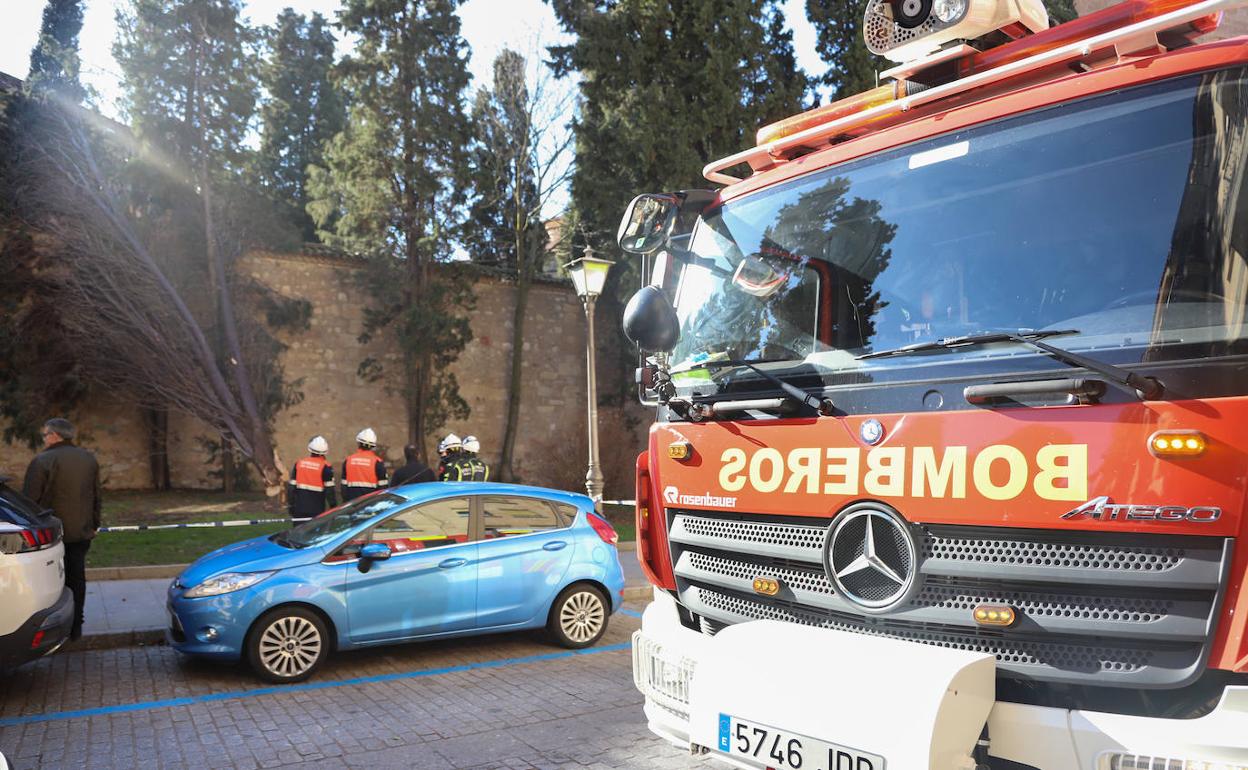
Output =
[{"x1": 308, "y1": 0, "x2": 472, "y2": 456}]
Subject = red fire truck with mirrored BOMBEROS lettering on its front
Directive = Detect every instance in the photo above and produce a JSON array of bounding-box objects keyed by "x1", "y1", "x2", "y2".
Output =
[{"x1": 619, "y1": 0, "x2": 1248, "y2": 770}]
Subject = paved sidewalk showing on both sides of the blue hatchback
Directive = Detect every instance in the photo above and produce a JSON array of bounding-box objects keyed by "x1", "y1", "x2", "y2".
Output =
[{"x1": 72, "y1": 544, "x2": 650, "y2": 649}]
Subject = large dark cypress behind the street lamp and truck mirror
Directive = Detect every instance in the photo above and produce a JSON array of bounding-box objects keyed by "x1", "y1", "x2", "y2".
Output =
[{"x1": 549, "y1": 0, "x2": 807, "y2": 401}]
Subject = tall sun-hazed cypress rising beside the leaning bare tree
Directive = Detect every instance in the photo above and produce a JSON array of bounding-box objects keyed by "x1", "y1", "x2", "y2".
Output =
[{"x1": 112, "y1": 0, "x2": 289, "y2": 489}]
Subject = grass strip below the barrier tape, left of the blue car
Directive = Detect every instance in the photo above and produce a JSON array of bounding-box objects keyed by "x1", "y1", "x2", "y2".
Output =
[{"x1": 86, "y1": 524, "x2": 290, "y2": 567}]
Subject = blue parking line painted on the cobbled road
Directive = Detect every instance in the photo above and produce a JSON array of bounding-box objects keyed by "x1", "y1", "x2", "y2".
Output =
[{"x1": 0, "y1": 641, "x2": 630, "y2": 728}]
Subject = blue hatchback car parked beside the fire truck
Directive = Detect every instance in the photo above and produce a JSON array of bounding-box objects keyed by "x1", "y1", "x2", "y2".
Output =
[{"x1": 167, "y1": 483, "x2": 624, "y2": 683}]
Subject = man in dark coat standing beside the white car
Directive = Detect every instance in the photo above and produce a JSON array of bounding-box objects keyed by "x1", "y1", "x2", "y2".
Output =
[{"x1": 22, "y1": 417, "x2": 100, "y2": 639}]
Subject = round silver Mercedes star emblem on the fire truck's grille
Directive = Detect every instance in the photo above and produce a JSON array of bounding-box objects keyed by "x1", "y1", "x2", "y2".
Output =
[{"x1": 824, "y1": 503, "x2": 919, "y2": 612}]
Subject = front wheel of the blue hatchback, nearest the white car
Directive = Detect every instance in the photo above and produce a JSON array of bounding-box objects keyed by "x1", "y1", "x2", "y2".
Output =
[{"x1": 247, "y1": 607, "x2": 329, "y2": 684}]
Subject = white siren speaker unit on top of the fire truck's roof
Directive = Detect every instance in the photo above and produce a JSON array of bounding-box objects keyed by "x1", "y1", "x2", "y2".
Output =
[{"x1": 862, "y1": 0, "x2": 1048, "y2": 64}]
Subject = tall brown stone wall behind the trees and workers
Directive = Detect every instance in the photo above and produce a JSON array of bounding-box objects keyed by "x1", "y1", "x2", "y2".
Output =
[{"x1": 0, "y1": 252, "x2": 649, "y2": 497}]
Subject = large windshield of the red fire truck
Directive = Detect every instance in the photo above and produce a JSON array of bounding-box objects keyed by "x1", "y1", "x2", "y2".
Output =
[{"x1": 673, "y1": 70, "x2": 1248, "y2": 383}]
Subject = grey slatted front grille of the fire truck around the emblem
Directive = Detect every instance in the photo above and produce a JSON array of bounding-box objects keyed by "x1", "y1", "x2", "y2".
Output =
[{"x1": 669, "y1": 510, "x2": 1232, "y2": 688}]
